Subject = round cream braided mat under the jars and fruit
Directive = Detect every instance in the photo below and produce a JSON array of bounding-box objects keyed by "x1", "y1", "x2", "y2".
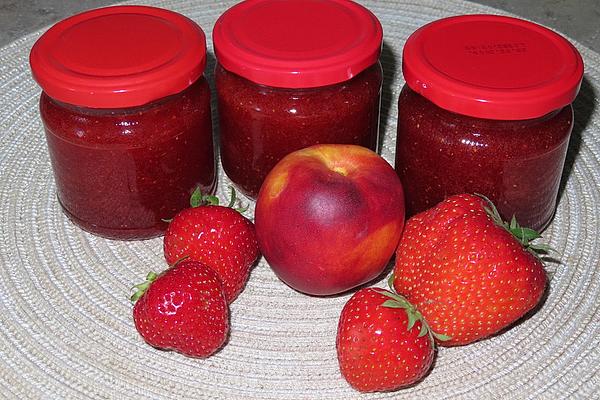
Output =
[{"x1": 0, "y1": 0, "x2": 600, "y2": 400}]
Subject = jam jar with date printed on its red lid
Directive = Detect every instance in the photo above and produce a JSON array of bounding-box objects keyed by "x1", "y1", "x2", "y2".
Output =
[{"x1": 395, "y1": 15, "x2": 583, "y2": 230}]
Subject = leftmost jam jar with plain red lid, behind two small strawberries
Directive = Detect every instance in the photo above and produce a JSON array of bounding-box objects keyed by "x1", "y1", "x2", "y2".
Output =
[{"x1": 30, "y1": 6, "x2": 216, "y2": 239}]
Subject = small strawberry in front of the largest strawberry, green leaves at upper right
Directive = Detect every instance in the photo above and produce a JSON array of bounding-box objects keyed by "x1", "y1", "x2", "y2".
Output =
[{"x1": 336, "y1": 288, "x2": 434, "y2": 392}]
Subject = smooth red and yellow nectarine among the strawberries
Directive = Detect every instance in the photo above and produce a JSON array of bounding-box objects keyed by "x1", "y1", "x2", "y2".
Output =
[{"x1": 255, "y1": 144, "x2": 404, "y2": 295}]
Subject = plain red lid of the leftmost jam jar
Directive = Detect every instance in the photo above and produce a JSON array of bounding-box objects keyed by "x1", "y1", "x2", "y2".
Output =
[{"x1": 29, "y1": 6, "x2": 206, "y2": 108}]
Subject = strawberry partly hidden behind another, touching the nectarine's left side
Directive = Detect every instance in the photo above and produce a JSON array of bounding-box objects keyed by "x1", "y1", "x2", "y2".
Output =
[{"x1": 163, "y1": 189, "x2": 259, "y2": 303}]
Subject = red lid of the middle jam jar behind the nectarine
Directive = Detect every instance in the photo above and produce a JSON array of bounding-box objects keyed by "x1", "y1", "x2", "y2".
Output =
[{"x1": 213, "y1": 0, "x2": 383, "y2": 88}]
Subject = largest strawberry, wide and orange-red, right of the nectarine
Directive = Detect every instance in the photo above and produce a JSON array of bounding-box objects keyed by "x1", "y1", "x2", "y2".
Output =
[{"x1": 394, "y1": 194, "x2": 547, "y2": 346}]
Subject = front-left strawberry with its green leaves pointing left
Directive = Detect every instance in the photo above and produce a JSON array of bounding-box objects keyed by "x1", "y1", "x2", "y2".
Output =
[{"x1": 131, "y1": 260, "x2": 229, "y2": 358}]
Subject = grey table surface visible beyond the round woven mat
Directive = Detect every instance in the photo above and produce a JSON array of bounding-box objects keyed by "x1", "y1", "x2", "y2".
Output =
[{"x1": 0, "y1": 0, "x2": 600, "y2": 52}]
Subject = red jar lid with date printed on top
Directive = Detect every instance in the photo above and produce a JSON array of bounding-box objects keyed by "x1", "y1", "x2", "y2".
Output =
[{"x1": 402, "y1": 15, "x2": 583, "y2": 120}]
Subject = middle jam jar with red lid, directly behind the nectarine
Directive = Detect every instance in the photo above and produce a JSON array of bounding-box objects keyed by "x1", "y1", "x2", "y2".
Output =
[{"x1": 213, "y1": 0, "x2": 383, "y2": 198}]
